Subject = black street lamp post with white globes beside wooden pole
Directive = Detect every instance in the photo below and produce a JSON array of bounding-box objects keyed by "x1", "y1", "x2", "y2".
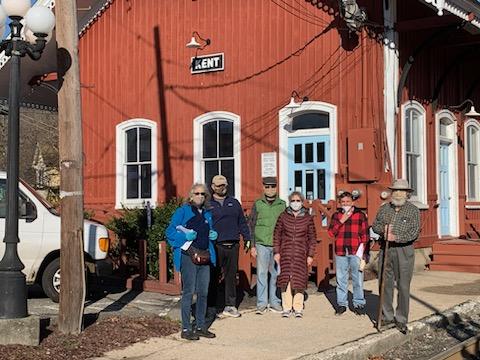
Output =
[{"x1": 0, "y1": 0, "x2": 55, "y2": 319}]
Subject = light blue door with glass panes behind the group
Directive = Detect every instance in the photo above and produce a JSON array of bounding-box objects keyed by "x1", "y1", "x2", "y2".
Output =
[{"x1": 288, "y1": 135, "x2": 331, "y2": 201}]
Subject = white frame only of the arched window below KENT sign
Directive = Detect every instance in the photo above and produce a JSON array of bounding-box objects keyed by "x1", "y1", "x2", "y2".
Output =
[{"x1": 193, "y1": 111, "x2": 242, "y2": 199}]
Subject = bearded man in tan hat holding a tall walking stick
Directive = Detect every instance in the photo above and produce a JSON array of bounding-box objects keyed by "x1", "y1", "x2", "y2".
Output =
[{"x1": 372, "y1": 179, "x2": 420, "y2": 334}]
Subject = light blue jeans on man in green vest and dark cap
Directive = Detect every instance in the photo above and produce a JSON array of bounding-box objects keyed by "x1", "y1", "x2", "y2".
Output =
[{"x1": 256, "y1": 244, "x2": 280, "y2": 308}]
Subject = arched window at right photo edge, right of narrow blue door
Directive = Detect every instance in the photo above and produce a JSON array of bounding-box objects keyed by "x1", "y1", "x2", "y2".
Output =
[{"x1": 465, "y1": 120, "x2": 480, "y2": 201}]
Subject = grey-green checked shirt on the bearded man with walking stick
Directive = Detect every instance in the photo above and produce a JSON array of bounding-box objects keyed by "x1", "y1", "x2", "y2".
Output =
[{"x1": 372, "y1": 201, "x2": 420, "y2": 243}]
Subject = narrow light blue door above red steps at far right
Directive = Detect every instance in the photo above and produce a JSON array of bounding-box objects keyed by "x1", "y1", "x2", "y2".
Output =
[{"x1": 438, "y1": 143, "x2": 451, "y2": 235}]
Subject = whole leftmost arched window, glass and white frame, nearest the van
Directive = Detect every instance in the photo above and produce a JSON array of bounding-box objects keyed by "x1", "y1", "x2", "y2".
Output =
[{"x1": 115, "y1": 119, "x2": 157, "y2": 208}]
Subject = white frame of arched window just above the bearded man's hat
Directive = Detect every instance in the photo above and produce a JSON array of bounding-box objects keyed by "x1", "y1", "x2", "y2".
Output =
[{"x1": 402, "y1": 100, "x2": 428, "y2": 209}]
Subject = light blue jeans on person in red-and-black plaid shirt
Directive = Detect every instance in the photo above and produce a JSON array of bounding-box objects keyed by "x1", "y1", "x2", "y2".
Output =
[{"x1": 335, "y1": 255, "x2": 365, "y2": 307}]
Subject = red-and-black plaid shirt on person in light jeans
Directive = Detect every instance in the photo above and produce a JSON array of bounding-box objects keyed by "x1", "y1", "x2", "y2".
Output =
[{"x1": 328, "y1": 208, "x2": 368, "y2": 256}]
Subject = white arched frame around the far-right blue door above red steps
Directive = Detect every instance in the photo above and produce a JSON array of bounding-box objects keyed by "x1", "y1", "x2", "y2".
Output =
[{"x1": 435, "y1": 110, "x2": 459, "y2": 236}]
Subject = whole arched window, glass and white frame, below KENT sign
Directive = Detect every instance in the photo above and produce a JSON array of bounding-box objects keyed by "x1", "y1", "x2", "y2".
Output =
[{"x1": 194, "y1": 111, "x2": 241, "y2": 198}]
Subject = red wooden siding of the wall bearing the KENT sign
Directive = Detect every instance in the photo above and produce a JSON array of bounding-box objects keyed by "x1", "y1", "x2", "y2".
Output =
[{"x1": 80, "y1": 0, "x2": 384, "y2": 217}]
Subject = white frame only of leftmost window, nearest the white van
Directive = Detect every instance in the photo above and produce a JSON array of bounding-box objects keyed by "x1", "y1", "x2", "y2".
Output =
[{"x1": 115, "y1": 119, "x2": 158, "y2": 209}]
